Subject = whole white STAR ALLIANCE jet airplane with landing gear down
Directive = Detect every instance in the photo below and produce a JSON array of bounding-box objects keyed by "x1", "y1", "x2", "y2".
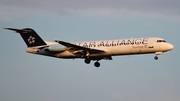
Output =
[{"x1": 4, "y1": 28, "x2": 174, "y2": 67}]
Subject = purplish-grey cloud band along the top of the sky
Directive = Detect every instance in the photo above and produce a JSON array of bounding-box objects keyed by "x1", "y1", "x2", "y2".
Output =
[{"x1": 0, "y1": 0, "x2": 180, "y2": 16}]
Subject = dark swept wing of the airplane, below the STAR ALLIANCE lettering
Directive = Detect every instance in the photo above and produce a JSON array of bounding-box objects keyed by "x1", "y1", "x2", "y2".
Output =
[{"x1": 55, "y1": 40, "x2": 105, "y2": 54}]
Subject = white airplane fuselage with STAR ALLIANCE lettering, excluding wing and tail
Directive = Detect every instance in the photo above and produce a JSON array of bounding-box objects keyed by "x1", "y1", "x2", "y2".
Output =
[{"x1": 26, "y1": 38, "x2": 173, "y2": 58}]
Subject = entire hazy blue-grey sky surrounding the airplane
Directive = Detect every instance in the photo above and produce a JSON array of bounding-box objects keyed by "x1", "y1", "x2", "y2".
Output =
[{"x1": 0, "y1": 0, "x2": 180, "y2": 101}]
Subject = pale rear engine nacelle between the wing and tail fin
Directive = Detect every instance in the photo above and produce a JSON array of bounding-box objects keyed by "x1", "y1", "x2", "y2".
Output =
[{"x1": 45, "y1": 45, "x2": 67, "y2": 52}]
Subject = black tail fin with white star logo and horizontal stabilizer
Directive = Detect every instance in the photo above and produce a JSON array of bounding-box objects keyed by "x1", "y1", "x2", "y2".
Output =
[{"x1": 4, "y1": 28, "x2": 47, "y2": 47}]
